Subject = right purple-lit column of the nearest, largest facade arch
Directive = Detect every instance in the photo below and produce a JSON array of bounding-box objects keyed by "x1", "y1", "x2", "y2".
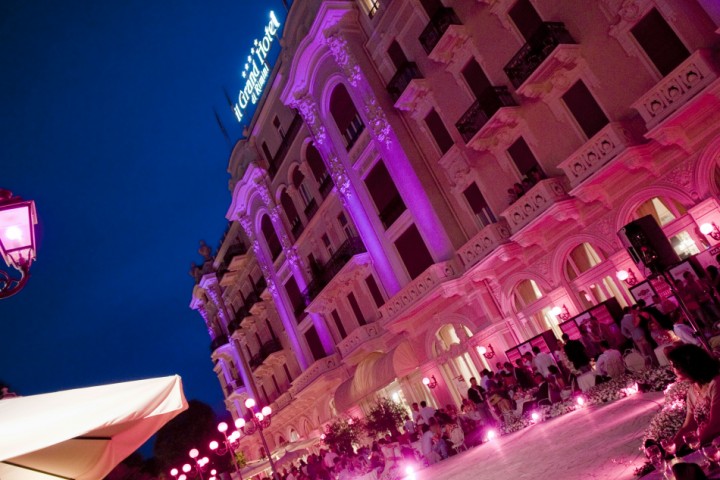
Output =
[{"x1": 325, "y1": 27, "x2": 455, "y2": 260}]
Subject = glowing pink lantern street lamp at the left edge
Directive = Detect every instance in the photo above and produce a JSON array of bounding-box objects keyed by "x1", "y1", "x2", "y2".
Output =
[{"x1": 0, "y1": 189, "x2": 37, "y2": 298}]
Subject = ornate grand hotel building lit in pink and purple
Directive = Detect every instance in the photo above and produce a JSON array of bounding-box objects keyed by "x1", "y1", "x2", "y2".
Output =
[{"x1": 190, "y1": 0, "x2": 720, "y2": 458}]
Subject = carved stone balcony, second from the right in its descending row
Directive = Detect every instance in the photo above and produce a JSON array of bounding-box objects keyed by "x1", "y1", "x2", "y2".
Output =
[{"x1": 558, "y1": 122, "x2": 635, "y2": 188}]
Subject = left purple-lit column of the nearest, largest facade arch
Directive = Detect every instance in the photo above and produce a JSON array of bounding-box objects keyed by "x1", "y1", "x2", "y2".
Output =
[{"x1": 291, "y1": 93, "x2": 401, "y2": 297}]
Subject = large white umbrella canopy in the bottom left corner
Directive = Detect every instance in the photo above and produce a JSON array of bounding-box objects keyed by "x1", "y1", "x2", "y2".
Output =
[{"x1": 0, "y1": 375, "x2": 187, "y2": 480}]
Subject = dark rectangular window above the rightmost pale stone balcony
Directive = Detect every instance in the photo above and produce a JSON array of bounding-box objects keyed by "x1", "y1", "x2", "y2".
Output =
[{"x1": 630, "y1": 8, "x2": 690, "y2": 76}]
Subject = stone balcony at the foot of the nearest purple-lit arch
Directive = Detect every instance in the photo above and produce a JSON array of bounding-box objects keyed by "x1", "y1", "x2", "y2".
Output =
[{"x1": 380, "y1": 260, "x2": 461, "y2": 323}]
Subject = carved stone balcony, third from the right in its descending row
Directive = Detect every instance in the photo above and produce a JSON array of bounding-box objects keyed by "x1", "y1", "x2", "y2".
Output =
[{"x1": 500, "y1": 177, "x2": 568, "y2": 234}]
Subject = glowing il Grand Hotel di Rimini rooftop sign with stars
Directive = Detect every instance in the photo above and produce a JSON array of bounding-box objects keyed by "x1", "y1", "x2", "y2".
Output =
[{"x1": 233, "y1": 12, "x2": 280, "y2": 122}]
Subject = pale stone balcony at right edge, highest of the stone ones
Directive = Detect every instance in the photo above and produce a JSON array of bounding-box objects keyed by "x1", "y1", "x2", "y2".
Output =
[{"x1": 632, "y1": 50, "x2": 718, "y2": 130}]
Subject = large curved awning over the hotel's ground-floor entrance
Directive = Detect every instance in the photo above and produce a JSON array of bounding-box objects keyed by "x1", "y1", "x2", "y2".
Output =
[{"x1": 335, "y1": 342, "x2": 418, "y2": 412}]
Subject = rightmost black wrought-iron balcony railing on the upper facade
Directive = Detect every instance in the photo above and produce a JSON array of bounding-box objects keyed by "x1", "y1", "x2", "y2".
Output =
[{"x1": 504, "y1": 22, "x2": 575, "y2": 88}]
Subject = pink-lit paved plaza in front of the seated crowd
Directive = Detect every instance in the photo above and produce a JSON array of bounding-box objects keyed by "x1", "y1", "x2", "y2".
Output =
[{"x1": 417, "y1": 393, "x2": 663, "y2": 480}]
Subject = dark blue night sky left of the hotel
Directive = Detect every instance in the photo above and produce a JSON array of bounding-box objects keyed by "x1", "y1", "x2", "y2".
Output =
[{"x1": 0, "y1": 0, "x2": 285, "y2": 411}]
